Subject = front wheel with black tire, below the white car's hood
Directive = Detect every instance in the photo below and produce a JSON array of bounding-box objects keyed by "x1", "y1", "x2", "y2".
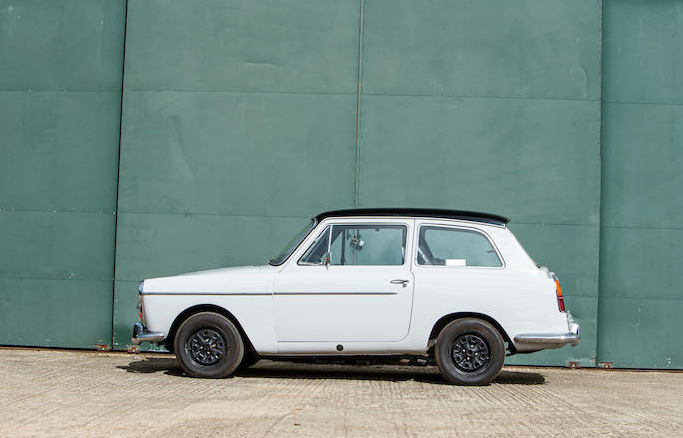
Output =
[{"x1": 173, "y1": 312, "x2": 244, "y2": 379}]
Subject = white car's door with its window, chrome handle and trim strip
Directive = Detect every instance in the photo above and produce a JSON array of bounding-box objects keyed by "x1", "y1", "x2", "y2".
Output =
[{"x1": 274, "y1": 219, "x2": 413, "y2": 342}]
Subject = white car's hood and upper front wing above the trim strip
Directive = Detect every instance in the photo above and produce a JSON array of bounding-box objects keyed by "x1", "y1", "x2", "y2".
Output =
[{"x1": 142, "y1": 265, "x2": 279, "y2": 294}]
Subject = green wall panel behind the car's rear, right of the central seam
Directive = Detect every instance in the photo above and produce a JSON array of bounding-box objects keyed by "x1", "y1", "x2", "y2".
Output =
[{"x1": 359, "y1": 0, "x2": 601, "y2": 365}]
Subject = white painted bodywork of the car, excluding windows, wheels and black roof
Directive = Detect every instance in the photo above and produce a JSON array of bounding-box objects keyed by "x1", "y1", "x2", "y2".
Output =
[{"x1": 140, "y1": 216, "x2": 578, "y2": 356}]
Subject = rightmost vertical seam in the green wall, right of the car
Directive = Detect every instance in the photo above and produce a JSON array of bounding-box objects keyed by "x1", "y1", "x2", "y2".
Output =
[{"x1": 593, "y1": 0, "x2": 605, "y2": 367}]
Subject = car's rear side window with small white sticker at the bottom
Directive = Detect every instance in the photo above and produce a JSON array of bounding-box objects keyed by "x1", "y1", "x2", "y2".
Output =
[{"x1": 417, "y1": 225, "x2": 503, "y2": 268}]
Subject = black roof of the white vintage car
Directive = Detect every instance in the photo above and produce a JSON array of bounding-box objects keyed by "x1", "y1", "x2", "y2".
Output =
[{"x1": 313, "y1": 208, "x2": 510, "y2": 227}]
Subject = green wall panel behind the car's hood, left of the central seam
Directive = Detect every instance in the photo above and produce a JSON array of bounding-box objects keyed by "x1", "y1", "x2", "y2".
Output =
[{"x1": 114, "y1": 0, "x2": 360, "y2": 348}]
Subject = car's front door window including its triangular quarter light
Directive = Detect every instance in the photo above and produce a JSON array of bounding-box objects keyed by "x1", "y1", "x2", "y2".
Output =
[{"x1": 300, "y1": 224, "x2": 407, "y2": 266}]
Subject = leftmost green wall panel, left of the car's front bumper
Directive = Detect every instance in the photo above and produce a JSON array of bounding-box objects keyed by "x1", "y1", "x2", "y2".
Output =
[{"x1": 0, "y1": 0, "x2": 125, "y2": 348}]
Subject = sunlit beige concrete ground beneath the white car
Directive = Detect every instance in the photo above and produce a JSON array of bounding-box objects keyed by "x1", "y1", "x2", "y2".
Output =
[{"x1": 0, "y1": 349, "x2": 683, "y2": 438}]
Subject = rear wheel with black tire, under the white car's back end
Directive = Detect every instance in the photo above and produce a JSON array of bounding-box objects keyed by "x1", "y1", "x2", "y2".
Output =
[{"x1": 434, "y1": 318, "x2": 505, "y2": 385}]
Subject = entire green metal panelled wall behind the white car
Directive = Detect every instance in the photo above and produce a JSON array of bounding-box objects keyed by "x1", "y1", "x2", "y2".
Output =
[{"x1": 0, "y1": 0, "x2": 683, "y2": 368}]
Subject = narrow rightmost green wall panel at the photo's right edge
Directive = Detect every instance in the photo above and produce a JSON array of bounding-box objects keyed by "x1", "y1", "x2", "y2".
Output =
[{"x1": 598, "y1": 0, "x2": 683, "y2": 368}]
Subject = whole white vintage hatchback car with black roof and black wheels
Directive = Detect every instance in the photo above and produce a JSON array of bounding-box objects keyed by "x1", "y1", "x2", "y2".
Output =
[{"x1": 133, "y1": 209, "x2": 579, "y2": 385}]
